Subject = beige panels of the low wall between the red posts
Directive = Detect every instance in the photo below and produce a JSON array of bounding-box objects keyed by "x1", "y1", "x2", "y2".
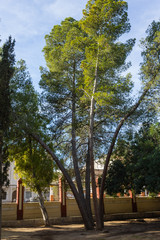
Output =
[{"x1": 2, "y1": 197, "x2": 160, "y2": 221}]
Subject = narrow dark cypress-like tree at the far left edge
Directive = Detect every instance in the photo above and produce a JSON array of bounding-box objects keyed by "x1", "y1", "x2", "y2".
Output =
[{"x1": 0, "y1": 37, "x2": 15, "y2": 239}]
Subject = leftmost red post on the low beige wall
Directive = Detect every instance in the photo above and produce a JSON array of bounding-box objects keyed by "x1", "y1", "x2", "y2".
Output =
[{"x1": 17, "y1": 179, "x2": 24, "y2": 220}]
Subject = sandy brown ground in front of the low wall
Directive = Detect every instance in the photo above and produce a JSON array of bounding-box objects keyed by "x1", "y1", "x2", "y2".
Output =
[{"x1": 2, "y1": 219, "x2": 160, "y2": 240}]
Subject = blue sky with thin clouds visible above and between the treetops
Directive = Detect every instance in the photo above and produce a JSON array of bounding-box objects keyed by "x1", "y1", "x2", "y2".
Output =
[{"x1": 0, "y1": 0, "x2": 160, "y2": 94}]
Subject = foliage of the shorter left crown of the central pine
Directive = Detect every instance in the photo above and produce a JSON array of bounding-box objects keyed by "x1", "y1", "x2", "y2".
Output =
[{"x1": 40, "y1": 18, "x2": 88, "y2": 164}]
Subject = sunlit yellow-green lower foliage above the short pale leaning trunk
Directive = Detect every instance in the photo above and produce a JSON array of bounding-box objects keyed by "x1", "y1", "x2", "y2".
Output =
[{"x1": 14, "y1": 138, "x2": 54, "y2": 192}]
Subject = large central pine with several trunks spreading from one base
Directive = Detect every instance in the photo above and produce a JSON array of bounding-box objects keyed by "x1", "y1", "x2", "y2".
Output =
[{"x1": 32, "y1": 0, "x2": 159, "y2": 230}]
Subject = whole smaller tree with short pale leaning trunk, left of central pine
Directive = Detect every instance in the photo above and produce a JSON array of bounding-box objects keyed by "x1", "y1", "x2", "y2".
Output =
[{"x1": 9, "y1": 60, "x2": 53, "y2": 226}]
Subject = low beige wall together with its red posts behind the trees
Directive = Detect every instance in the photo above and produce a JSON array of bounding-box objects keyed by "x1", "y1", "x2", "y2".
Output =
[{"x1": 2, "y1": 179, "x2": 160, "y2": 220}]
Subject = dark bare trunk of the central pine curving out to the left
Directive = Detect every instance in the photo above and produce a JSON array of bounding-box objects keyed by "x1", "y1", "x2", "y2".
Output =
[{"x1": 31, "y1": 133, "x2": 94, "y2": 230}]
